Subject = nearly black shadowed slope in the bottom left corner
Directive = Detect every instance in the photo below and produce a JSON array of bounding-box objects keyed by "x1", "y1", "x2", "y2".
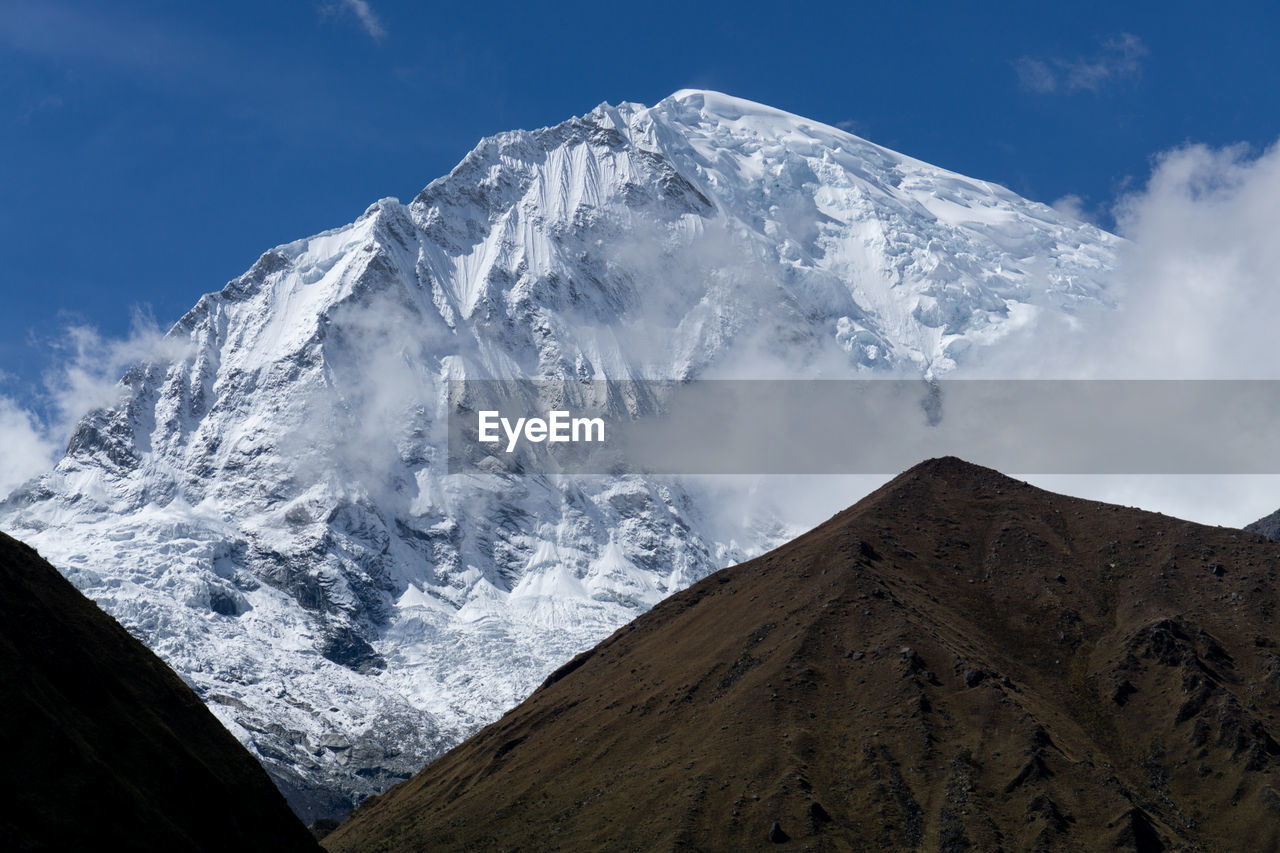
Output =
[{"x1": 0, "y1": 534, "x2": 315, "y2": 852}]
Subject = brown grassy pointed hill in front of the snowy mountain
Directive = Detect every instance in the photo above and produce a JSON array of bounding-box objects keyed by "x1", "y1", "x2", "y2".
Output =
[{"x1": 325, "y1": 459, "x2": 1280, "y2": 852}]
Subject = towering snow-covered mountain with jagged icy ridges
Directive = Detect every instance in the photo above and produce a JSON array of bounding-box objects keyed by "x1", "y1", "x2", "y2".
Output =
[{"x1": 0, "y1": 91, "x2": 1117, "y2": 820}]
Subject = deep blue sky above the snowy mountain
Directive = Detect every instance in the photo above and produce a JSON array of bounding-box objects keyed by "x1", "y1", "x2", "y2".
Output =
[{"x1": 0, "y1": 0, "x2": 1280, "y2": 409}]
